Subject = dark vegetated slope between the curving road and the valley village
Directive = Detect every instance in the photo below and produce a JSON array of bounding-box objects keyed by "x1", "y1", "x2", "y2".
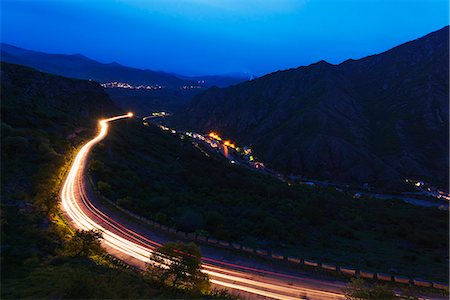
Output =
[{"x1": 90, "y1": 120, "x2": 448, "y2": 282}]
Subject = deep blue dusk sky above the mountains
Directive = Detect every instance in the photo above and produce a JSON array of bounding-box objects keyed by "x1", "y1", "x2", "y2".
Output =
[{"x1": 1, "y1": 0, "x2": 449, "y2": 75}]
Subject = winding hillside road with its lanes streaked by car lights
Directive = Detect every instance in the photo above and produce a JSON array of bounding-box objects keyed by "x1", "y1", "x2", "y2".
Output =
[{"x1": 60, "y1": 113, "x2": 344, "y2": 299}]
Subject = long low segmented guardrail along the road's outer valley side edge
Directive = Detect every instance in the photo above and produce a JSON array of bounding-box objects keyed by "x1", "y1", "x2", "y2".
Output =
[{"x1": 88, "y1": 176, "x2": 449, "y2": 290}]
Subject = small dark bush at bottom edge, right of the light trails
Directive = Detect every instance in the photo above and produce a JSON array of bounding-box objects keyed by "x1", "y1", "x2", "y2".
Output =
[{"x1": 344, "y1": 278, "x2": 397, "y2": 300}]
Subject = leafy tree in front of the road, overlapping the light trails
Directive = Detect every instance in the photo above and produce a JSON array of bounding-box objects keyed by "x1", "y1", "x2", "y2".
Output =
[{"x1": 146, "y1": 242, "x2": 210, "y2": 292}]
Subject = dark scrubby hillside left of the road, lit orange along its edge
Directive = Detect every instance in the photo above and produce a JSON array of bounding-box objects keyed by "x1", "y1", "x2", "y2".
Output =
[{"x1": 0, "y1": 63, "x2": 225, "y2": 299}]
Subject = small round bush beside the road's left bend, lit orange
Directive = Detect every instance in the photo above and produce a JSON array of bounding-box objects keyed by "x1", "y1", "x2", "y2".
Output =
[{"x1": 63, "y1": 229, "x2": 102, "y2": 256}]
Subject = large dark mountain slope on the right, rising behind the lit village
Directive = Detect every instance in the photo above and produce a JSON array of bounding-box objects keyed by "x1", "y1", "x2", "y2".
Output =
[{"x1": 173, "y1": 26, "x2": 449, "y2": 188}]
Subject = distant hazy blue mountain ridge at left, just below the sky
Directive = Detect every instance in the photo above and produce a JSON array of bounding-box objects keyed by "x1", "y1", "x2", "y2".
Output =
[{"x1": 0, "y1": 43, "x2": 196, "y2": 87}]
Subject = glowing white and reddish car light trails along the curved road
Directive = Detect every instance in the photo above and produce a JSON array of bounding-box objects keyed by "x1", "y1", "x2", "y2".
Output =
[{"x1": 61, "y1": 113, "x2": 343, "y2": 299}]
